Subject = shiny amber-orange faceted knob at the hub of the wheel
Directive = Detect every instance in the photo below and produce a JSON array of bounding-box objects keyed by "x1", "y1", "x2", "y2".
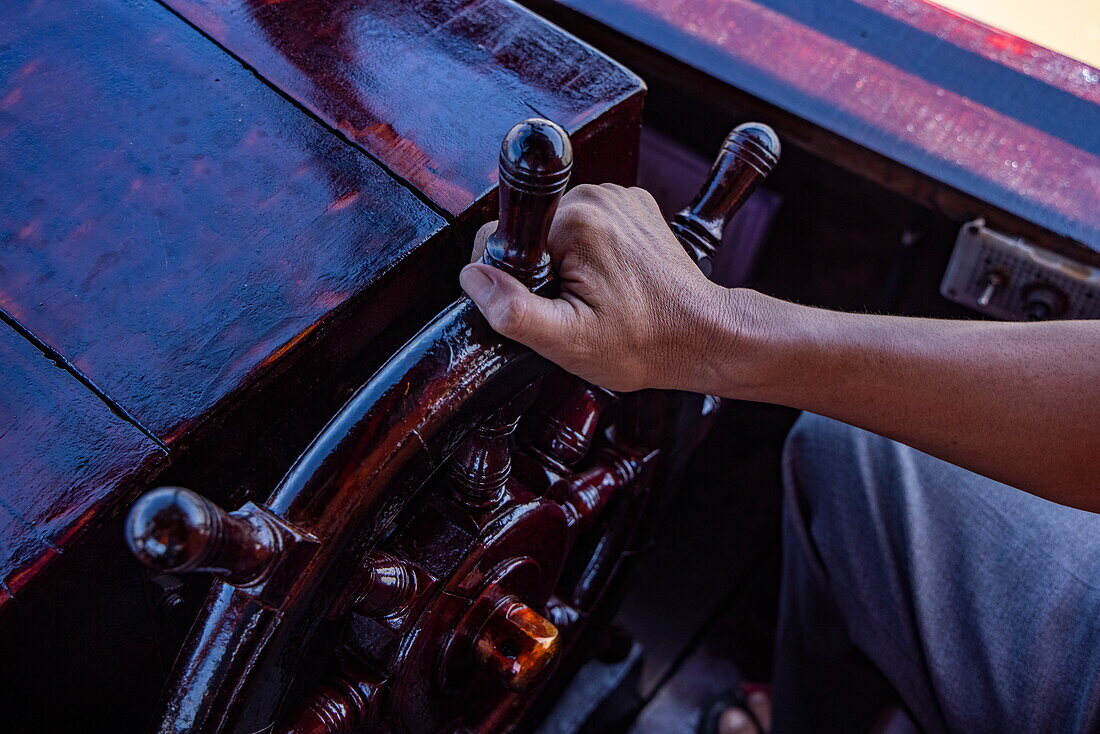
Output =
[{"x1": 474, "y1": 598, "x2": 561, "y2": 693}]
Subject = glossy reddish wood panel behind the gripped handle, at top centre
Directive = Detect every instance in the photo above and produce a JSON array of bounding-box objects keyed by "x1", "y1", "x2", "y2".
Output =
[{"x1": 166, "y1": 0, "x2": 644, "y2": 217}]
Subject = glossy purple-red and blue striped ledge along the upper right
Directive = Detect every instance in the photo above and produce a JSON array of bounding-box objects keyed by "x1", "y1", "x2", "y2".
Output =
[{"x1": 528, "y1": 0, "x2": 1100, "y2": 250}]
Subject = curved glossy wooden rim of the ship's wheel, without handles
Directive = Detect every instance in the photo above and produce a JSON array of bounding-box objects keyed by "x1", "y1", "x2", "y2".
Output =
[{"x1": 146, "y1": 298, "x2": 550, "y2": 732}]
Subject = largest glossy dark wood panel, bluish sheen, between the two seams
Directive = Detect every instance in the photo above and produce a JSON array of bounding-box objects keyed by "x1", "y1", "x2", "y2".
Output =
[{"x1": 0, "y1": 0, "x2": 446, "y2": 445}]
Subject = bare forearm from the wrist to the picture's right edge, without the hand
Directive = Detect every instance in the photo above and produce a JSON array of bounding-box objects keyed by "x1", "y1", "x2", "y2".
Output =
[{"x1": 699, "y1": 291, "x2": 1100, "y2": 511}]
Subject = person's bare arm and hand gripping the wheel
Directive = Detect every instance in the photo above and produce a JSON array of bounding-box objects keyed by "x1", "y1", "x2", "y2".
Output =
[{"x1": 462, "y1": 186, "x2": 1100, "y2": 511}]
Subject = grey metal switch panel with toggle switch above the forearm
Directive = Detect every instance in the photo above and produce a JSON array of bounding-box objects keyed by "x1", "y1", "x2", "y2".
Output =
[{"x1": 939, "y1": 219, "x2": 1100, "y2": 321}]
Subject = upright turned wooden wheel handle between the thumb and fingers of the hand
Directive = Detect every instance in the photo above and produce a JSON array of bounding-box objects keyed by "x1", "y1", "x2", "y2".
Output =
[{"x1": 482, "y1": 118, "x2": 573, "y2": 289}]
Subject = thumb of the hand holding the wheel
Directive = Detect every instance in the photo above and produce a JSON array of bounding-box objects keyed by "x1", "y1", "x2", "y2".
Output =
[{"x1": 459, "y1": 263, "x2": 562, "y2": 349}]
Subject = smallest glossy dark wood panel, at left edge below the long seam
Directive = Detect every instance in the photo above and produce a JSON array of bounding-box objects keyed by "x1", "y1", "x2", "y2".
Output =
[{"x1": 0, "y1": 321, "x2": 166, "y2": 612}]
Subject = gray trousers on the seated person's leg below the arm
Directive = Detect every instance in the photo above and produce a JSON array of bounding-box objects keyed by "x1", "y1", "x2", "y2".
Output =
[{"x1": 774, "y1": 414, "x2": 1100, "y2": 734}]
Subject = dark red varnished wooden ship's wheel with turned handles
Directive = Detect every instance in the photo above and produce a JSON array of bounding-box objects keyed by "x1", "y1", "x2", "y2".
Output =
[{"x1": 127, "y1": 120, "x2": 779, "y2": 734}]
